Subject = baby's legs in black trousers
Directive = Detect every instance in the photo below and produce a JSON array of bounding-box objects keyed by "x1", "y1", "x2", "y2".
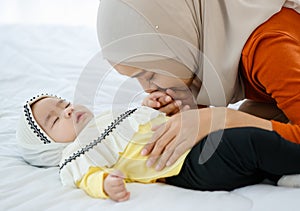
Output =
[{"x1": 166, "y1": 127, "x2": 300, "y2": 190}]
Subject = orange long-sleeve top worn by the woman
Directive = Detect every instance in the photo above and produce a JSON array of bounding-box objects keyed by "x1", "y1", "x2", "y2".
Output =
[{"x1": 241, "y1": 8, "x2": 300, "y2": 144}]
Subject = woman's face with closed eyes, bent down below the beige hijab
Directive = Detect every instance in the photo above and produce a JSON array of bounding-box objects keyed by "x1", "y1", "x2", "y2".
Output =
[{"x1": 114, "y1": 64, "x2": 192, "y2": 93}]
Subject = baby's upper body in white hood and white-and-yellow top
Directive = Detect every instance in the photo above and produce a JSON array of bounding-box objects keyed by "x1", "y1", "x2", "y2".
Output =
[{"x1": 17, "y1": 95, "x2": 188, "y2": 201}]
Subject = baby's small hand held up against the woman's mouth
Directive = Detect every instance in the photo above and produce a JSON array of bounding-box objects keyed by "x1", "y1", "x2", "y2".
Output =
[{"x1": 142, "y1": 91, "x2": 182, "y2": 116}]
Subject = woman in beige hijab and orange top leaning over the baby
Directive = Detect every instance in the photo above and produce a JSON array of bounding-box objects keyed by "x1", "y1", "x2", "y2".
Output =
[{"x1": 99, "y1": 0, "x2": 300, "y2": 187}]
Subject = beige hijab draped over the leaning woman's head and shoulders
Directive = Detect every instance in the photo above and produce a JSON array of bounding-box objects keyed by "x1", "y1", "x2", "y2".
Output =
[{"x1": 98, "y1": 0, "x2": 299, "y2": 106}]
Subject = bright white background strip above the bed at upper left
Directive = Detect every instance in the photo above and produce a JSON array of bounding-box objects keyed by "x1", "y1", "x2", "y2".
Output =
[{"x1": 0, "y1": 0, "x2": 100, "y2": 27}]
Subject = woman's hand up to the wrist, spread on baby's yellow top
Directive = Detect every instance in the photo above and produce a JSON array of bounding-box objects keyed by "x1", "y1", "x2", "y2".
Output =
[{"x1": 142, "y1": 110, "x2": 209, "y2": 170}]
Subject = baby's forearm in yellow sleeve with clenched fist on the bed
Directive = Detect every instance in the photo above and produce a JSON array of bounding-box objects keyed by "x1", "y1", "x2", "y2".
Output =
[{"x1": 76, "y1": 167, "x2": 130, "y2": 201}]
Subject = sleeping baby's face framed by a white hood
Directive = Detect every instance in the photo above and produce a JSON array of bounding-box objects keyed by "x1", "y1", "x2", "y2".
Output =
[{"x1": 32, "y1": 97, "x2": 93, "y2": 143}]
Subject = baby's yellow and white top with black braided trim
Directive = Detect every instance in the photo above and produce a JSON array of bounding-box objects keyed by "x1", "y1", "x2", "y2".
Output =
[{"x1": 60, "y1": 107, "x2": 189, "y2": 198}]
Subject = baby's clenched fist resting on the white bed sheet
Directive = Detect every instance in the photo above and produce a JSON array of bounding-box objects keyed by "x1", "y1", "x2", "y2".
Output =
[{"x1": 104, "y1": 170, "x2": 130, "y2": 202}]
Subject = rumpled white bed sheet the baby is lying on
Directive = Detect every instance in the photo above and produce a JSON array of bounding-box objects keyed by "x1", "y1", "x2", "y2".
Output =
[{"x1": 0, "y1": 25, "x2": 300, "y2": 211}]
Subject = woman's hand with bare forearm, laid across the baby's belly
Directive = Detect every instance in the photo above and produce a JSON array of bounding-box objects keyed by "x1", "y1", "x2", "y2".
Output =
[{"x1": 141, "y1": 107, "x2": 272, "y2": 170}]
